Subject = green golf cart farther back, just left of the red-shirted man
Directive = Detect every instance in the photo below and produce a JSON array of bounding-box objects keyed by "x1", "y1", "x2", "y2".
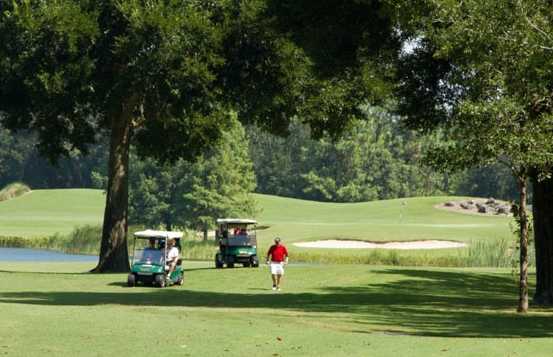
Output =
[{"x1": 215, "y1": 218, "x2": 259, "y2": 269}]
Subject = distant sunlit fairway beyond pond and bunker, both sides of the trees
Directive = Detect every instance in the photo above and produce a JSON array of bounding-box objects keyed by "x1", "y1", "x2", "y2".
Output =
[{"x1": 0, "y1": 189, "x2": 511, "y2": 242}]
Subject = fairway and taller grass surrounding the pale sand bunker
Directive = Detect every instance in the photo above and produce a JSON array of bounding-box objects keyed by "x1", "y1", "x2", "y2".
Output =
[{"x1": 251, "y1": 195, "x2": 516, "y2": 266}]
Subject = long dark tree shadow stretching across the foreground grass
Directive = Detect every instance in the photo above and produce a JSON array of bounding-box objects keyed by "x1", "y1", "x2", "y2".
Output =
[{"x1": 0, "y1": 269, "x2": 553, "y2": 338}]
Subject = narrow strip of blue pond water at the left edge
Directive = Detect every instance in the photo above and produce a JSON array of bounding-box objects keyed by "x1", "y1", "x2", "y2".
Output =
[{"x1": 0, "y1": 248, "x2": 98, "y2": 262}]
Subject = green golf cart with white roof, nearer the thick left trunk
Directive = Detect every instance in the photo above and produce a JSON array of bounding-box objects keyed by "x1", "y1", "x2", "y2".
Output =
[{"x1": 127, "y1": 229, "x2": 184, "y2": 288}]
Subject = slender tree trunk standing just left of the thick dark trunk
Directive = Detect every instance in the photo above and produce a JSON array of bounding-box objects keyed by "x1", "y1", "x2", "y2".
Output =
[{"x1": 517, "y1": 176, "x2": 528, "y2": 313}]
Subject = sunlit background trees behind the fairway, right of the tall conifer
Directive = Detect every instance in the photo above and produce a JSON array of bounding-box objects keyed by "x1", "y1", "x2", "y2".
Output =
[{"x1": 250, "y1": 107, "x2": 449, "y2": 202}]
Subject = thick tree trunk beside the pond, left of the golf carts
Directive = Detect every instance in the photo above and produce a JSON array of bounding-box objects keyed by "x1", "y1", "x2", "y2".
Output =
[{"x1": 92, "y1": 106, "x2": 132, "y2": 273}]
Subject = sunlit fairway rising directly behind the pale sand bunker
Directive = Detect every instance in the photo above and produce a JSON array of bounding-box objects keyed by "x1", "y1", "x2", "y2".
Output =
[{"x1": 256, "y1": 195, "x2": 511, "y2": 242}]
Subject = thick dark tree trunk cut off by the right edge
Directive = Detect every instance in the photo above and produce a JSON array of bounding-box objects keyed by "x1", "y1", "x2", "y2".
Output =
[{"x1": 532, "y1": 175, "x2": 553, "y2": 305}]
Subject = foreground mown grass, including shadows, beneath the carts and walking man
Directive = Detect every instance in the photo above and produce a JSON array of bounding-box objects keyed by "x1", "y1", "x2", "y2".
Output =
[{"x1": 0, "y1": 262, "x2": 553, "y2": 357}]
